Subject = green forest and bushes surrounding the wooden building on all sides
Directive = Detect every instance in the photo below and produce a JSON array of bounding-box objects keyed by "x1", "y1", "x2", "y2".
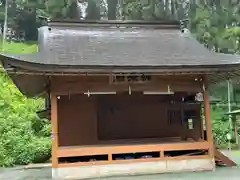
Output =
[{"x1": 0, "y1": 0, "x2": 240, "y2": 166}]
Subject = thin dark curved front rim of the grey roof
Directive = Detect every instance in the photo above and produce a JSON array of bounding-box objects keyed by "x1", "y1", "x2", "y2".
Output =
[{"x1": 0, "y1": 54, "x2": 240, "y2": 74}]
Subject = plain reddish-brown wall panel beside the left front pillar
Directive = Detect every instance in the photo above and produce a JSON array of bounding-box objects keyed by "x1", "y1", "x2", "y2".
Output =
[{"x1": 58, "y1": 95, "x2": 98, "y2": 146}]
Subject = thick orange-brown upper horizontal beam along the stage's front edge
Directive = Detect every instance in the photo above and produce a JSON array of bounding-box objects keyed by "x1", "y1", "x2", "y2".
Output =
[{"x1": 57, "y1": 141, "x2": 209, "y2": 158}]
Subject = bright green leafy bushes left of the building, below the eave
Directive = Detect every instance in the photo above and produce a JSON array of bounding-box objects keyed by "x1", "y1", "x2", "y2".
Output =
[{"x1": 0, "y1": 74, "x2": 51, "y2": 167}]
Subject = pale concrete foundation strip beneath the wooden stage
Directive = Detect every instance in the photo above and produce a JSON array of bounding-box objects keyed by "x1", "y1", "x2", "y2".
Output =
[{"x1": 52, "y1": 159, "x2": 215, "y2": 180}]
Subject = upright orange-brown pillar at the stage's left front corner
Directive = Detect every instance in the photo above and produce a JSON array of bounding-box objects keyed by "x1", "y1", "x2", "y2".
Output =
[{"x1": 51, "y1": 94, "x2": 58, "y2": 168}]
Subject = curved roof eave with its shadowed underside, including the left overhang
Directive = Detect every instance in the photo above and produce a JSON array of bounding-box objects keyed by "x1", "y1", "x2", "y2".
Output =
[{"x1": 0, "y1": 52, "x2": 240, "y2": 97}]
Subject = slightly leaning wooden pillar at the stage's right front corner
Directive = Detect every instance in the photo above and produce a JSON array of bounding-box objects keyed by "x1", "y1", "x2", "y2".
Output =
[{"x1": 202, "y1": 79, "x2": 215, "y2": 158}]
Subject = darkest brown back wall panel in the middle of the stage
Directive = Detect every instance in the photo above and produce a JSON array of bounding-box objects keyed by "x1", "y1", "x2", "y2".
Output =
[{"x1": 98, "y1": 93, "x2": 180, "y2": 140}]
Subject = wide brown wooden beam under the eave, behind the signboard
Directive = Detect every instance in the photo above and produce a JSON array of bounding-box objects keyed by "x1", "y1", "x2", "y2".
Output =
[{"x1": 51, "y1": 76, "x2": 201, "y2": 95}]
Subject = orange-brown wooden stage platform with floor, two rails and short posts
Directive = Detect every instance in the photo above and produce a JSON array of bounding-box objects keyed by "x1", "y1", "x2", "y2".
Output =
[{"x1": 57, "y1": 138, "x2": 210, "y2": 167}]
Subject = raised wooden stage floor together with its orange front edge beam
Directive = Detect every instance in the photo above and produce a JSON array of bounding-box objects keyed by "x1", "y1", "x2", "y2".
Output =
[{"x1": 57, "y1": 138, "x2": 209, "y2": 157}]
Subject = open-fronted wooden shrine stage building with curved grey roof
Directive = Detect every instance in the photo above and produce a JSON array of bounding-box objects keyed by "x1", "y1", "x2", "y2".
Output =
[{"x1": 0, "y1": 22, "x2": 240, "y2": 179}]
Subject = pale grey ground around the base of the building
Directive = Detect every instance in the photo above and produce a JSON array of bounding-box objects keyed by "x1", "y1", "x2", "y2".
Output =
[{"x1": 0, "y1": 152, "x2": 240, "y2": 180}]
